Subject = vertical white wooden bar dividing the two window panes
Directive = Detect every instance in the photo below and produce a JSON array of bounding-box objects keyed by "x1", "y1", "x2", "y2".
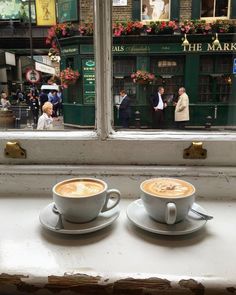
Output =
[{"x1": 94, "y1": 0, "x2": 113, "y2": 140}]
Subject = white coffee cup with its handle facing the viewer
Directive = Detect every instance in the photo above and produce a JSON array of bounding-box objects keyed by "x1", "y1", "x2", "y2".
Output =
[{"x1": 140, "y1": 177, "x2": 195, "y2": 224}]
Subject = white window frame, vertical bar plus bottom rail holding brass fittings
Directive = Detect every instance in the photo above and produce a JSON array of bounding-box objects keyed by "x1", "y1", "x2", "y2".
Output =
[{"x1": 0, "y1": 0, "x2": 236, "y2": 166}]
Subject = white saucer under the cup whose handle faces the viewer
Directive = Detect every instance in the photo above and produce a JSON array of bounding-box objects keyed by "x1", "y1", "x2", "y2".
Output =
[{"x1": 126, "y1": 199, "x2": 207, "y2": 236}]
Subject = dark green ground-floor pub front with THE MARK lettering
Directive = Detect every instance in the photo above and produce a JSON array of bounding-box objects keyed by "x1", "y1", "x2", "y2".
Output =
[{"x1": 60, "y1": 34, "x2": 236, "y2": 128}]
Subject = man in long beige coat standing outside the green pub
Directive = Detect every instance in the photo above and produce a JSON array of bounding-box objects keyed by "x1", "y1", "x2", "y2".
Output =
[{"x1": 174, "y1": 87, "x2": 189, "y2": 129}]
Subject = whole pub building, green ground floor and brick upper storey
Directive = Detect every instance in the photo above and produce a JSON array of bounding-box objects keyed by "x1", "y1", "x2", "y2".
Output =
[{"x1": 59, "y1": 0, "x2": 236, "y2": 128}]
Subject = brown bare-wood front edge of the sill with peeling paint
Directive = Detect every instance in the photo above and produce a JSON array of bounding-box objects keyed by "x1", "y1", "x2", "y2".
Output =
[{"x1": 0, "y1": 273, "x2": 236, "y2": 295}]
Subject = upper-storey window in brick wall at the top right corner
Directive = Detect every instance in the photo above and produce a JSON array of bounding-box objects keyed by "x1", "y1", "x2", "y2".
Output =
[{"x1": 201, "y1": 0, "x2": 230, "y2": 18}]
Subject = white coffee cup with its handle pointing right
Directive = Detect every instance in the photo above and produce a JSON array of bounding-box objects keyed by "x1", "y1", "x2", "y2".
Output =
[{"x1": 52, "y1": 178, "x2": 120, "y2": 223}]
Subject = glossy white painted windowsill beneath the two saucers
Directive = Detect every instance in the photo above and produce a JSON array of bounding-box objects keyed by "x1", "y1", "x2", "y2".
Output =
[{"x1": 0, "y1": 196, "x2": 236, "y2": 295}]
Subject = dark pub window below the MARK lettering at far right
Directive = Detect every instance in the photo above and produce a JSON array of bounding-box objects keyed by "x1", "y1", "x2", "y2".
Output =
[{"x1": 199, "y1": 55, "x2": 232, "y2": 103}]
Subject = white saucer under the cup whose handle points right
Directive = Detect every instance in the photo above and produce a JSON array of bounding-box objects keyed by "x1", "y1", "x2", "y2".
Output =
[{"x1": 39, "y1": 203, "x2": 120, "y2": 235}]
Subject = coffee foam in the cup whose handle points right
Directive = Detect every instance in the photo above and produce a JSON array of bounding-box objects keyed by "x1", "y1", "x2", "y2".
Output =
[{"x1": 56, "y1": 180, "x2": 104, "y2": 198}]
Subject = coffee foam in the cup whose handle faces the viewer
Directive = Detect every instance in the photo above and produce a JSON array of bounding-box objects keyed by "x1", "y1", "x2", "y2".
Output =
[{"x1": 141, "y1": 178, "x2": 195, "y2": 198}]
